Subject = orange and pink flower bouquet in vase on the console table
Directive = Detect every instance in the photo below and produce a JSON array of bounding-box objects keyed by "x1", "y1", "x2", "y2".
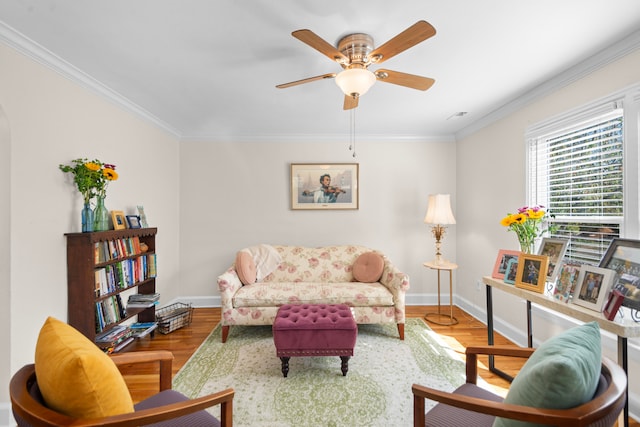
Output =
[{"x1": 500, "y1": 205, "x2": 553, "y2": 254}]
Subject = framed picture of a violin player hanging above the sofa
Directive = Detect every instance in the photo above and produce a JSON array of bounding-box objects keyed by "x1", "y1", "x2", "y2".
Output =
[{"x1": 291, "y1": 163, "x2": 359, "y2": 210}]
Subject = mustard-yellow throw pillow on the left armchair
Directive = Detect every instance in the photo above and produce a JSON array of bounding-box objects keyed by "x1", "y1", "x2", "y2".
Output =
[{"x1": 35, "y1": 317, "x2": 133, "y2": 418}]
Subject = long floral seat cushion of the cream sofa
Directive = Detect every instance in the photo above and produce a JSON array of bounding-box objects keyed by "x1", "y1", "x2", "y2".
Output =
[{"x1": 233, "y1": 282, "x2": 393, "y2": 308}]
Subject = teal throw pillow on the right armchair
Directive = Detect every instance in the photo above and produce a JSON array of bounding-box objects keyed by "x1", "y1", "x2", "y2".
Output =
[{"x1": 493, "y1": 322, "x2": 602, "y2": 427}]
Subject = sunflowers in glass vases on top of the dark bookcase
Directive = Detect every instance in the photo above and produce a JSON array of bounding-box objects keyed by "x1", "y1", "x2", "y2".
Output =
[{"x1": 59, "y1": 159, "x2": 118, "y2": 232}]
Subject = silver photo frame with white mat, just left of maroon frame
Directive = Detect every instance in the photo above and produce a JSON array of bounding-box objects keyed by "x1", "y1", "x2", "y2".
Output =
[{"x1": 571, "y1": 264, "x2": 615, "y2": 311}]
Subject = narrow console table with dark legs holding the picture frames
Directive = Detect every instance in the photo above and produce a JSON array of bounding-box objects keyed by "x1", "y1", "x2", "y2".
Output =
[{"x1": 482, "y1": 276, "x2": 640, "y2": 427}]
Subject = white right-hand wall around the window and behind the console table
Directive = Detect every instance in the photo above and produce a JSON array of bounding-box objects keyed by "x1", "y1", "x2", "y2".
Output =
[{"x1": 456, "y1": 51, "x2": 640, "y2": 418}]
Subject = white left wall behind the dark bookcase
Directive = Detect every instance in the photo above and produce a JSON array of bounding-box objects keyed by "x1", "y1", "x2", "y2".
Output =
[{"x1": 0, "y1": 40, "x2": 179, "y2": 414}]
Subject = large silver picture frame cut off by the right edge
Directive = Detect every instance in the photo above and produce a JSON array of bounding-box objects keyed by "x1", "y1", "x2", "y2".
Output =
[{"x1": 599, "y1": 238, "x2": 640, "y2": 310}]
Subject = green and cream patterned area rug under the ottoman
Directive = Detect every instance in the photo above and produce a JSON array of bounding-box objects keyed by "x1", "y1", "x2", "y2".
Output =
[{"x1": 173, "y1": 319, "x2": 464, "y2": 427}]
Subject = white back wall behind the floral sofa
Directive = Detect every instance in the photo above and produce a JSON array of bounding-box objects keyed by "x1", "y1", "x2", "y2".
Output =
[{"x1": 180, "y1": 139, "x2": 456, "y2": 297}]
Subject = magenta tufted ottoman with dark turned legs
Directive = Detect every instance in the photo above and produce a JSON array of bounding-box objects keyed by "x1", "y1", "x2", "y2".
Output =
[{"x1": 273, "y1": 304, "x2": 358, "y2": 377}]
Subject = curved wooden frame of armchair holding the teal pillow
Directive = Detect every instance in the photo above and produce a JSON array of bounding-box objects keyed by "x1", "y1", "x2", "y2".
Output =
[{"x1": 412, "y1": 346, "x2": 627, "y2": 427}]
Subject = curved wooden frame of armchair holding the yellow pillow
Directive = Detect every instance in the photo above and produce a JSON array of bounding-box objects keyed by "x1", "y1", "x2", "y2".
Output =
[{"x1": 9, "y1": 350, "x2": 234, "y2": 427}]
